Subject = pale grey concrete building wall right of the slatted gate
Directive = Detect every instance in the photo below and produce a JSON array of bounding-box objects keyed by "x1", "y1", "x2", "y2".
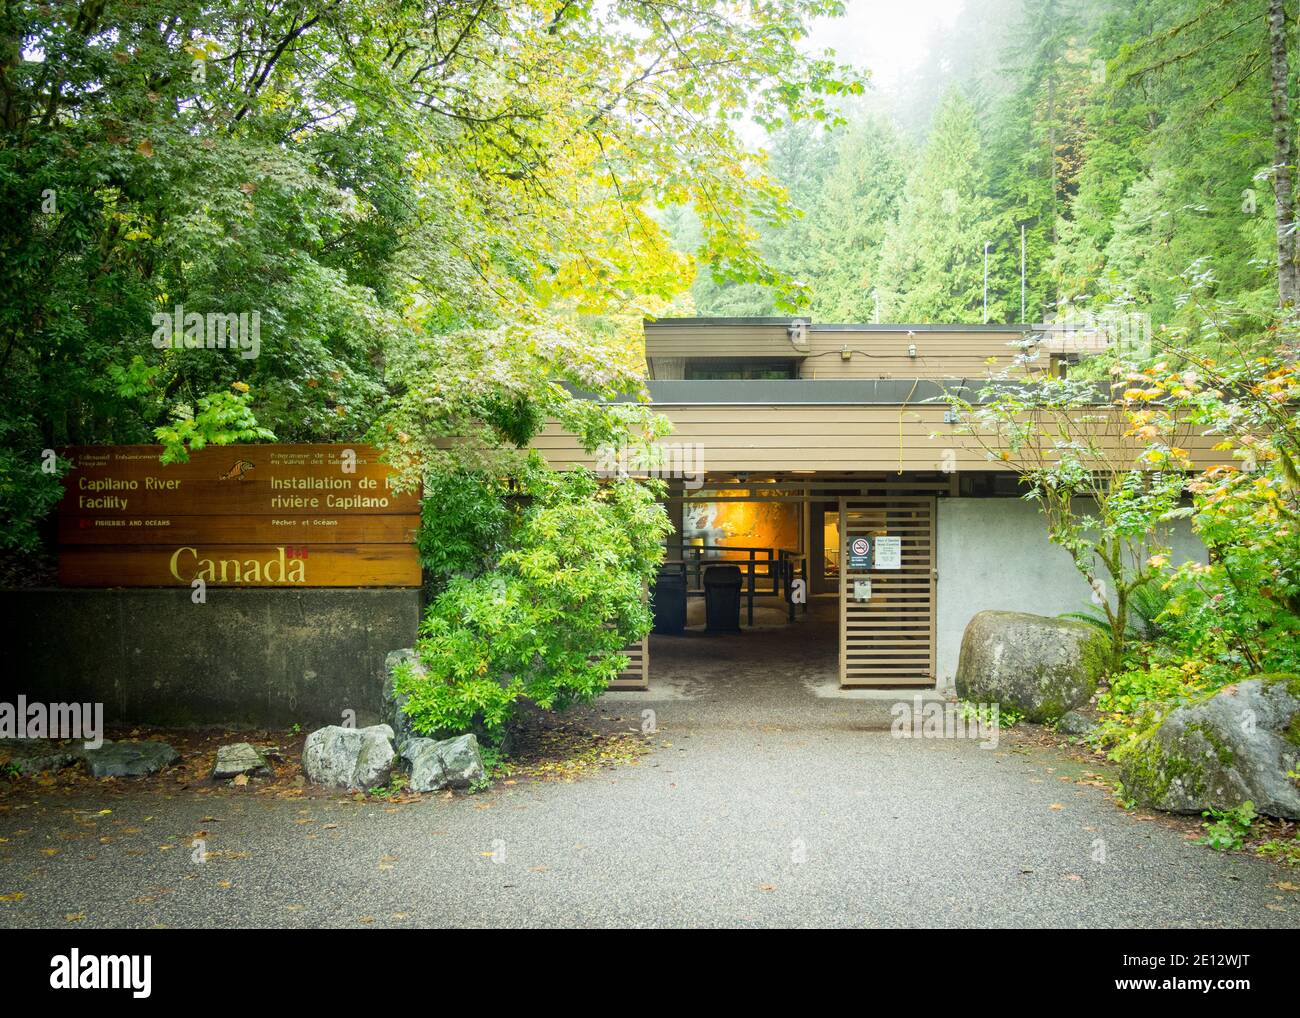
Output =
[{"x1": 935, "y1": 498, "x2": 1206, "y2": 689}]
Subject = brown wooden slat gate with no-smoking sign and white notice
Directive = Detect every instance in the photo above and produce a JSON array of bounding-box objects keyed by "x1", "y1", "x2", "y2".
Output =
[{"x1": 840, "y1": 495, "x2": 935, "y2": 686}]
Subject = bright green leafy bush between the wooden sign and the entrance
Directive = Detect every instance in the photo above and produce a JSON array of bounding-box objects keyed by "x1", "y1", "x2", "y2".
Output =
[{"x1": 395, "y1": 454, "x2": 670, "y2": 742}]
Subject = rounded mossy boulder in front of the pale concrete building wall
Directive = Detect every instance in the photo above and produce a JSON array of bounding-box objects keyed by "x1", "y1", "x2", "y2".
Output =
[{"x1": 956, "y1": 611, "x2": 1106, "y2": 722}]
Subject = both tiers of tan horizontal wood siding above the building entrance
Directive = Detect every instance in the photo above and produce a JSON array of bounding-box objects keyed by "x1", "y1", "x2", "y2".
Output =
[{"x1": 533, "y1": 319, "x2": 1217, "y2": 484}]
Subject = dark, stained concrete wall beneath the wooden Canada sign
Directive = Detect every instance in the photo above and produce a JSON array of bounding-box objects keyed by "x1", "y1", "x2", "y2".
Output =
[{"x1": 0, "y1": 588, "x2": 420, "y2": 728}]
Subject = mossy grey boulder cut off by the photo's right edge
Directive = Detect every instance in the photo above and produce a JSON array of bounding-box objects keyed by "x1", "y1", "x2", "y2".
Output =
[{"x1": 1121, "y1": 675, "x2": 1300, "y2": 820}]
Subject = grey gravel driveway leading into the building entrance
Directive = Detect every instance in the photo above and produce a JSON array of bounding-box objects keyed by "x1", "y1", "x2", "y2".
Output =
[{"x1": 0, "y1": 616, "x2": 1300, "y2": 928}]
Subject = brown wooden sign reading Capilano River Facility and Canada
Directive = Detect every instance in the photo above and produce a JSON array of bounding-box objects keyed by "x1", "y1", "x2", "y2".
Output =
[{"x1": 59, "y1": 445, "x2": 421, "y2": 586}]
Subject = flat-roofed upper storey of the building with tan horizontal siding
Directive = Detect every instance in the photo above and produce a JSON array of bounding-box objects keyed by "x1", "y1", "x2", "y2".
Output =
[{"x1": 645, "y1": 319, "x2": 1104, "y2": 381}]
